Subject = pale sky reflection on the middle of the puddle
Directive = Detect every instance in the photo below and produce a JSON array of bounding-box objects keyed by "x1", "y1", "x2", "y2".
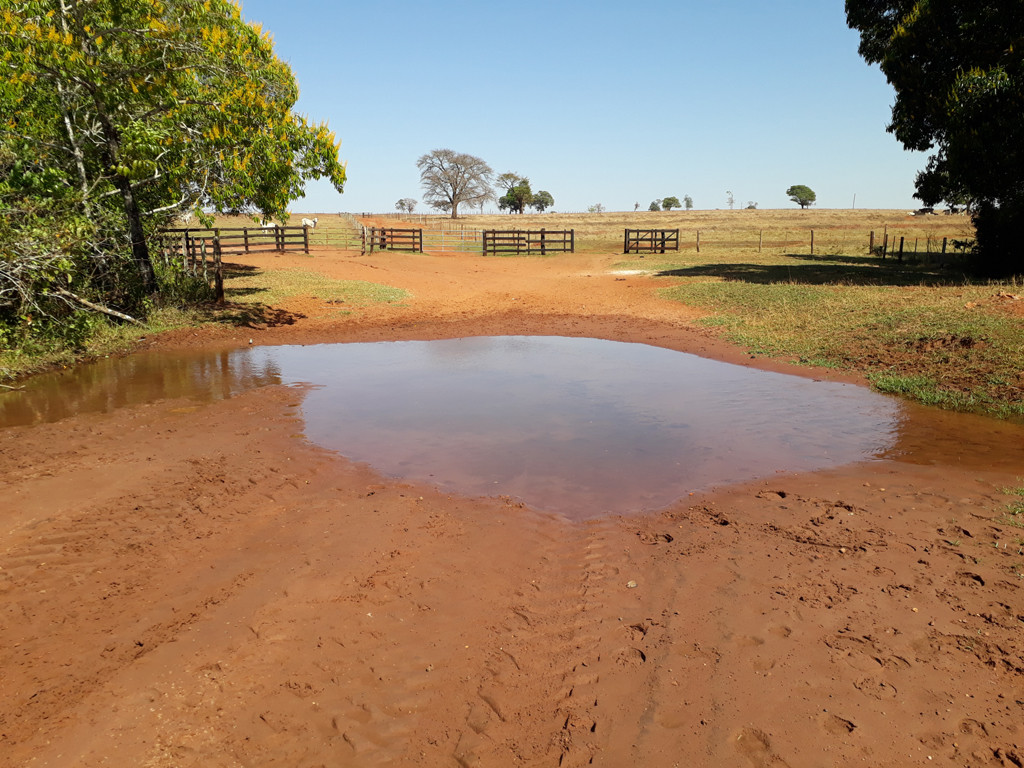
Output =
[{"x1": 260, "y1": 337, "x2": 901, "y2": 518}]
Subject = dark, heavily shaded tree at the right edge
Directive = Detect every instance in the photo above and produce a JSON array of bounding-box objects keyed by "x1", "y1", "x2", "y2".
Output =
[{"x1": 846, "y1": 0, "x2": 1024, "y2": 274}]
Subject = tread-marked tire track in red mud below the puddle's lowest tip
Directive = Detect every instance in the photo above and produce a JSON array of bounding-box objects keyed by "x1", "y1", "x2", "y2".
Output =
[{"x1": 454, "y1": 522, "x2": 622, "y2": 768}]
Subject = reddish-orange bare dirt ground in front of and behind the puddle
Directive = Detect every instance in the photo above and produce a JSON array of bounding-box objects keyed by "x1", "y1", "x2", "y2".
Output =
[{"x1": 0, "y1": 252, "x2": 1024, "y2": 768}]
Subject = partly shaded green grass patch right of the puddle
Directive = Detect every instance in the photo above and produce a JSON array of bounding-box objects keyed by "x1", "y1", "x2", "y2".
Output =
[{"x1": 651, "y1": 254, "x2": 1024, "y2": 419}]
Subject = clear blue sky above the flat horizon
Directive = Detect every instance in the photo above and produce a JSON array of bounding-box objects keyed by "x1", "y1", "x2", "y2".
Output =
[{"x1": 235, "y1": 0, "x2": 926, "y2": 212}]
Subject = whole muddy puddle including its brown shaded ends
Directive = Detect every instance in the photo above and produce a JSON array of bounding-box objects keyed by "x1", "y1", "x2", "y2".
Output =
[{"x1": 0, "y1": 337, "x2": 1024, "y2": 519}]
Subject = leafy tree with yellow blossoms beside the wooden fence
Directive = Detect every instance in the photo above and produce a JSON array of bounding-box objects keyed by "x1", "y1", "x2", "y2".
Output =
[{"x1": 0, "y1": 0, "x2": 345, "y2": 333}]
